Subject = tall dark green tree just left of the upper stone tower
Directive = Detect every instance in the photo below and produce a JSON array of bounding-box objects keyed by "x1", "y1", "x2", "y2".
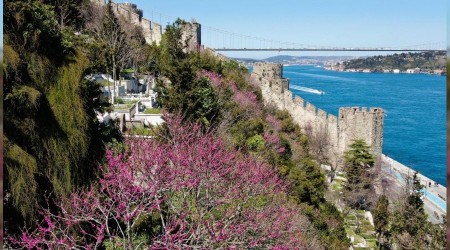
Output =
[{"x1": 156, "y1": 19, "x2": 220, "y2": 125}]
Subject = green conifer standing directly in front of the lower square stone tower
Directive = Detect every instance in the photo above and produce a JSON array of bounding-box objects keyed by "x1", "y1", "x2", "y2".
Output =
[{"x1": 344, "y1": 140, "x2": 375, "y2": 209}]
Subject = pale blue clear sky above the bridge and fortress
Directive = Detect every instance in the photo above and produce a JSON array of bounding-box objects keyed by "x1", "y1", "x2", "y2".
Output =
[{"x1": 125, "y1": 0, "x2": 447, "y2": 56}]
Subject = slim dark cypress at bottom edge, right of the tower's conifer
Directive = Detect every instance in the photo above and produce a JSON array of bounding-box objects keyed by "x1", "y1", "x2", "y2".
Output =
[{"x1": 373, "y1": 195, "x2": 390, "y2": 249}]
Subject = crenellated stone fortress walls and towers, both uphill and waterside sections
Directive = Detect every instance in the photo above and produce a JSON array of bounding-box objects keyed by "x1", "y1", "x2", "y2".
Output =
[{"x1": 91, "y1": 0, "x2": 384, "y2": 166}]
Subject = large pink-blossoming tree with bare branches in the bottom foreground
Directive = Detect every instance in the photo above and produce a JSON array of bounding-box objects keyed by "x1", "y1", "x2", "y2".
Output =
[{"x1": 9, "y1": 115, "x2": 308, "y2": 249}]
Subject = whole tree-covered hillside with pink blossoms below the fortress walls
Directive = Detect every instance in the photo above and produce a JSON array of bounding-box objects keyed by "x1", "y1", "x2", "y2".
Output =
[{"x1": 3, "y1": 0, "x2": 444, "y2": 249}]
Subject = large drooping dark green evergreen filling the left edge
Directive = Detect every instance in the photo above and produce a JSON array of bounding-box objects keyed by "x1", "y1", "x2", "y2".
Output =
[{"x1": 3, "y1": 0, "x2": 134, "y2": 232}]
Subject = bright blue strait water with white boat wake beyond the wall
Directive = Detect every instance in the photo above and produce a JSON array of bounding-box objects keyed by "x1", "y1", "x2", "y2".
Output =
[{"x1": 283, "y1": 65, "x2": 446, "y2": 186}]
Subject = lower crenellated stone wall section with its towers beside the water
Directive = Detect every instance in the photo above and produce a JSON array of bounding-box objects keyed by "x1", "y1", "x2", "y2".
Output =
[{"x1": 252, "y1": 63, "x2": 384, "y2": 166}]
